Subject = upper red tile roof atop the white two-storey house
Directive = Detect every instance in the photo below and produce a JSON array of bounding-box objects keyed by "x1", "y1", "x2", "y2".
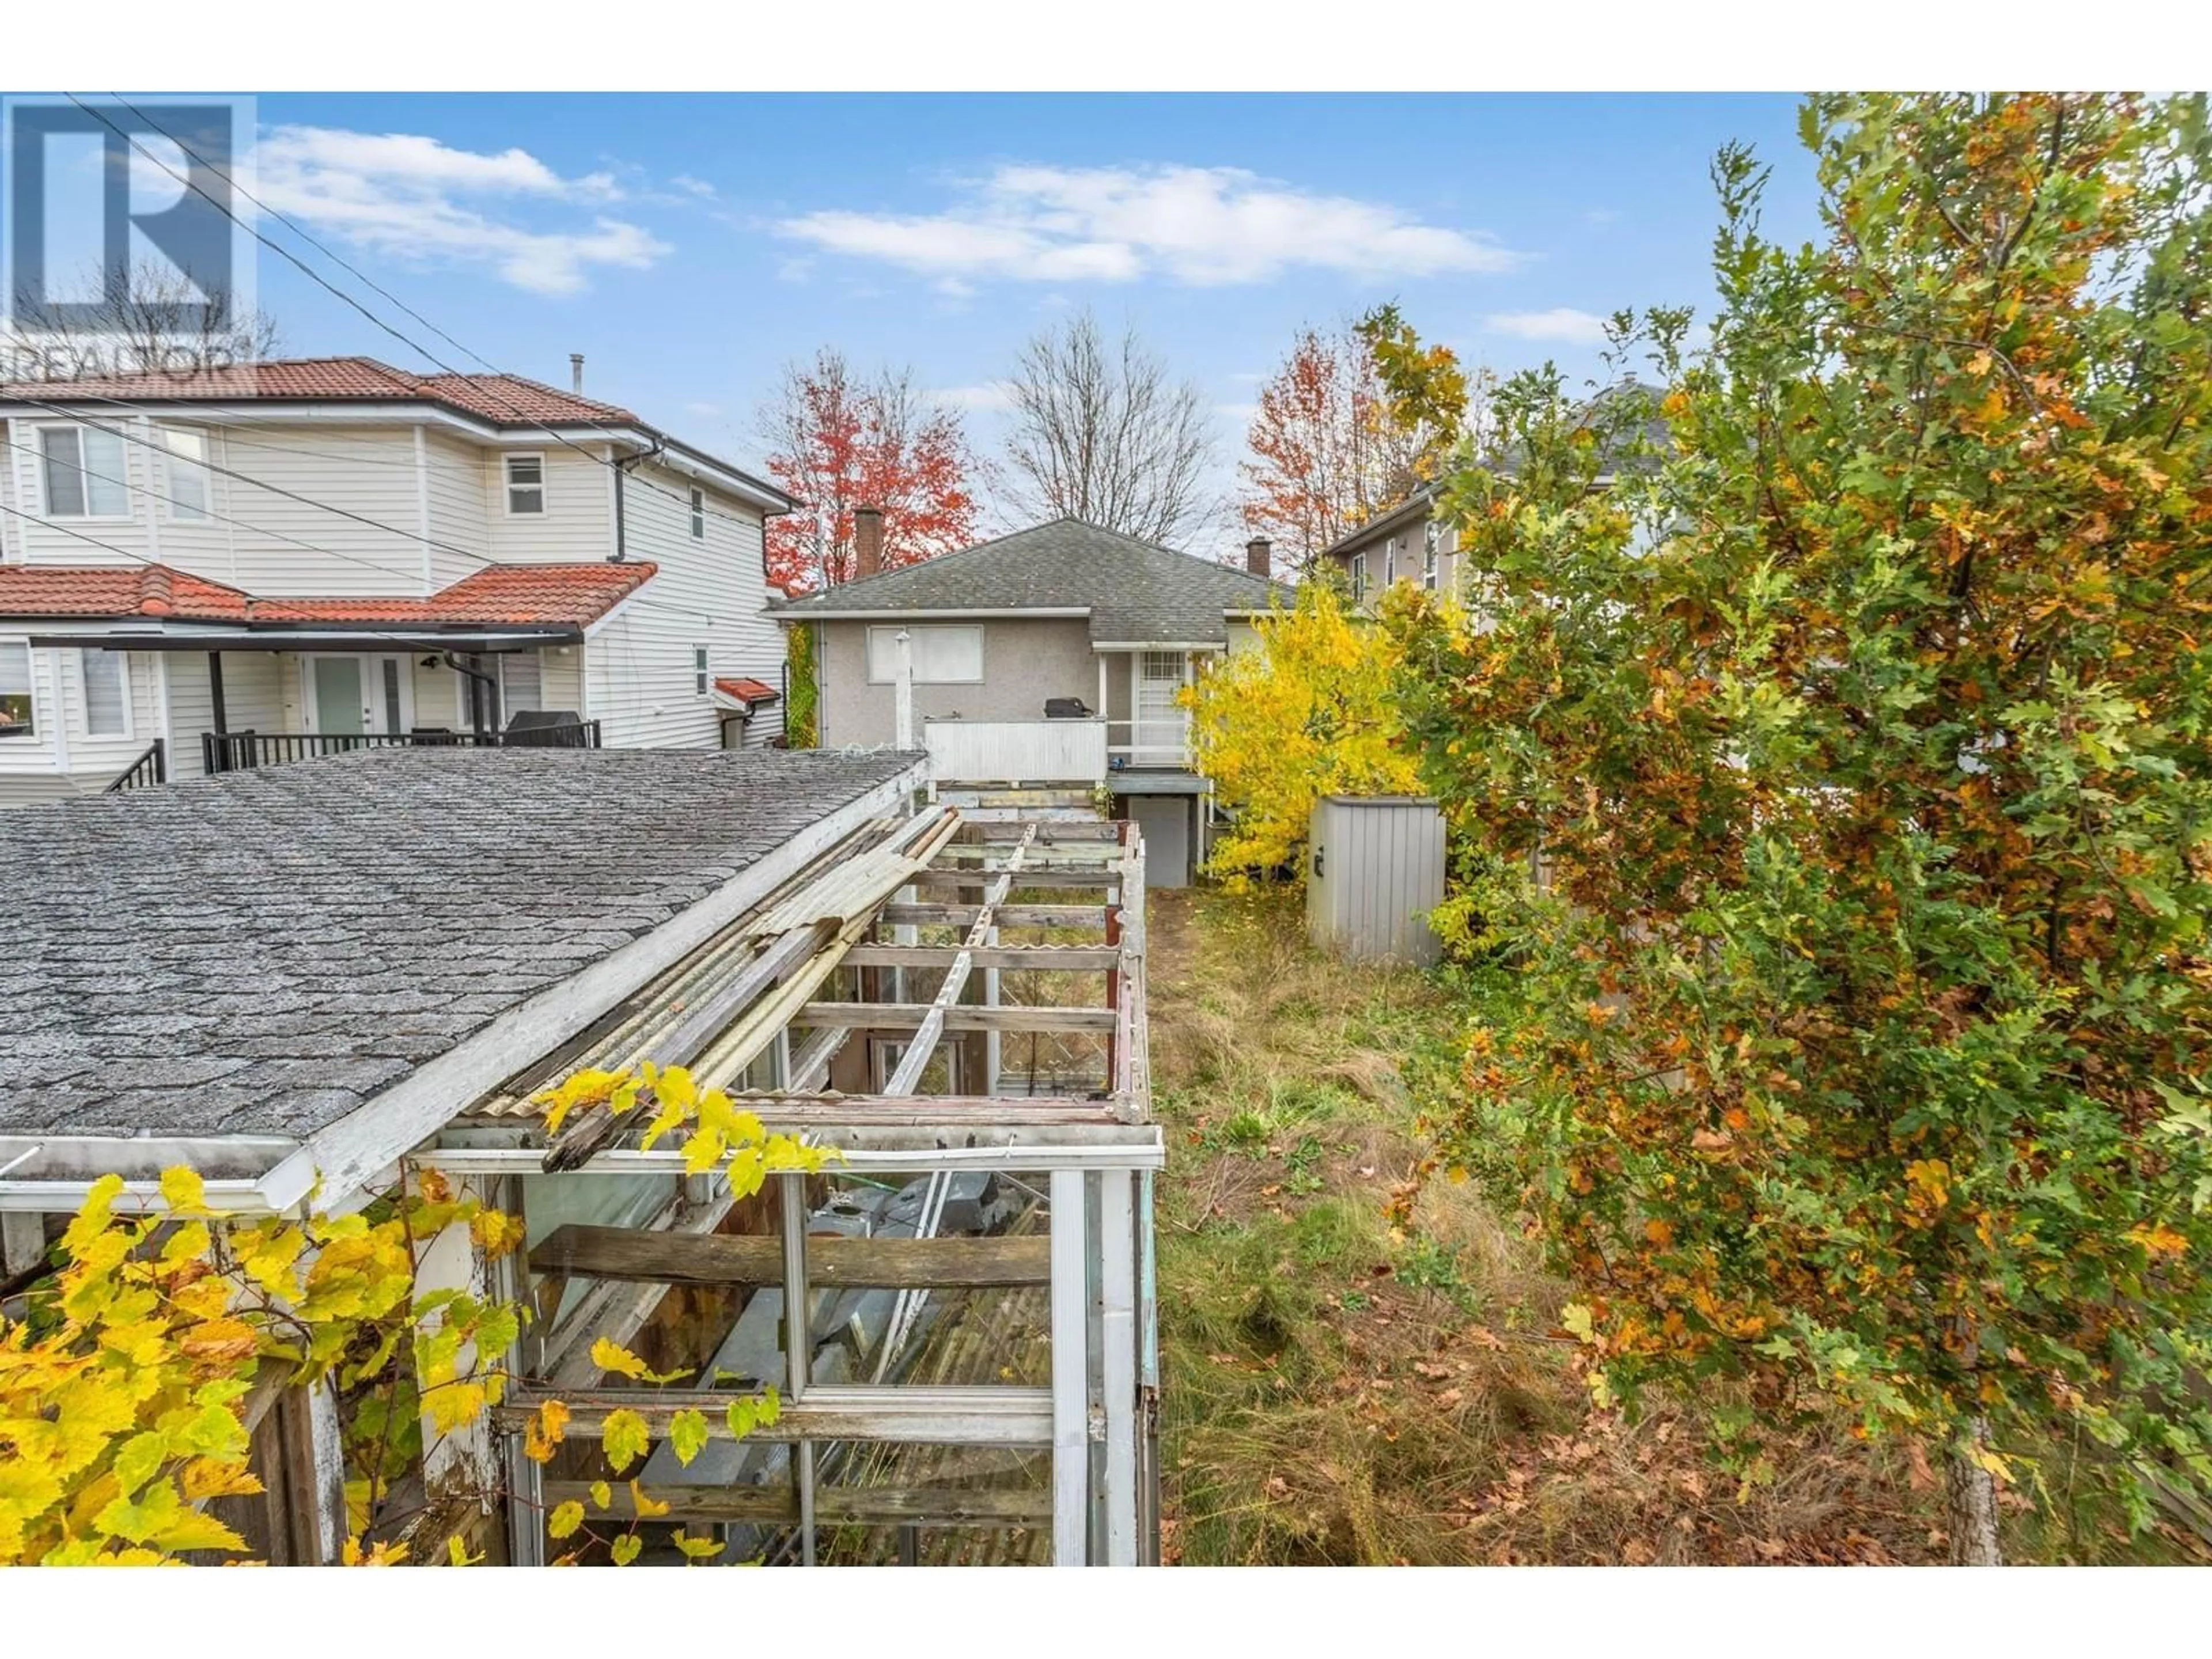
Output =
[{"x1": 0, "y1": 356, "x2": 643, "y2": 427}]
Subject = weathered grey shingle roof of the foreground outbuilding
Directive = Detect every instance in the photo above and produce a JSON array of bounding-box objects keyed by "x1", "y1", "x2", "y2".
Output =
[{"x1": 0, "y1": 750, "x2": 918, "y2": 1137}]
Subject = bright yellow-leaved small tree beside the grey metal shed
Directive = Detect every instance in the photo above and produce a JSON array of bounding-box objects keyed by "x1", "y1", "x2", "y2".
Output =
[{"x1": 1183, "y1": 582, "x2": 1416, "y2": 889}]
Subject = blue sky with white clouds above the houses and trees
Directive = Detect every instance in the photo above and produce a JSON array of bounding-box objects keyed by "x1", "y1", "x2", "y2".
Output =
[{"x1": 259, "y1": 93, "x2": 1814, "y2": 548}]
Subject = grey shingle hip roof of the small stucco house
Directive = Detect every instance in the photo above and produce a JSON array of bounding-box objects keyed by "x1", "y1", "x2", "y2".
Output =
[{"x1": 772, "y1": 518, "x2": 1292, "y2": 643}]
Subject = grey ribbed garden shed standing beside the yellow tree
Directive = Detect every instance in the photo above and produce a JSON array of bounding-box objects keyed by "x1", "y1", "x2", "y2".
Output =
[{"x1": 1305, "y1": 794, "x2": 1445, "y2": 967}]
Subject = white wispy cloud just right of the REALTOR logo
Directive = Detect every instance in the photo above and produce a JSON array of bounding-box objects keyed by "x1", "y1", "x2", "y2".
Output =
[{"x1": 255, "y1": 126, "x2": 671, "y2": 294}]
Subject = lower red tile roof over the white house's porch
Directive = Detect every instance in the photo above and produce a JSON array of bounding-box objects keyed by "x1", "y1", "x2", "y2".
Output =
[{"x1": 0, "y1": 564, "x2": 659, "y2": 628}]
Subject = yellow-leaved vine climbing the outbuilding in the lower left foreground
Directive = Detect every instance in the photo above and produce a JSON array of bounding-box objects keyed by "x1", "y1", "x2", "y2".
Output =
[{"x1": 0, "y1": 1066, "x2": 834, "y2": 1566}]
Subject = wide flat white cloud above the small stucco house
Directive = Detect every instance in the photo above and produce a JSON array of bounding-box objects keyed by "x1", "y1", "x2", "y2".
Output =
[{"x1": 774, "y1": 166, "x2": 1520, "y2": 287}]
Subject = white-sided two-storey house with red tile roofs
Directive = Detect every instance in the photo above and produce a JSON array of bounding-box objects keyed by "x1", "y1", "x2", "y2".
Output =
[{"x1": 0, "y1": 358, "x2": 792, "y2": 803}]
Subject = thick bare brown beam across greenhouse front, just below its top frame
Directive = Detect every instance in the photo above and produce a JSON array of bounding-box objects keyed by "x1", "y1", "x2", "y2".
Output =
[{"x1": 531, "y1": 1224, "x2": 1051, "y2": 1290}]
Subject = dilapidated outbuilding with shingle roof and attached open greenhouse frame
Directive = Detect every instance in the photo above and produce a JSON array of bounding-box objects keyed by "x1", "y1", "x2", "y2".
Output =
[{"x1": 0, "y1": 752, "x2": 1164, "y2": 1566}]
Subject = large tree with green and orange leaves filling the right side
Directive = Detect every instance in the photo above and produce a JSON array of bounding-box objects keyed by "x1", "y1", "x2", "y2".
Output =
[{"x1": 1400, "y1": 95, "x2": 2212, "y2": 1562}]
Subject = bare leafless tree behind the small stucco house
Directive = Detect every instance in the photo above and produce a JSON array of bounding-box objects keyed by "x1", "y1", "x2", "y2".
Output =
[{"x1": 1004, "y1": 312, "x2": 1221, "y2": 546}]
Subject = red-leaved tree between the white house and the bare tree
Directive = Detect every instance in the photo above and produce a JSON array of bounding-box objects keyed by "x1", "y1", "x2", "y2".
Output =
[{"x1": 759, "y1": 345, "x2": 975, "y2": 593}]
